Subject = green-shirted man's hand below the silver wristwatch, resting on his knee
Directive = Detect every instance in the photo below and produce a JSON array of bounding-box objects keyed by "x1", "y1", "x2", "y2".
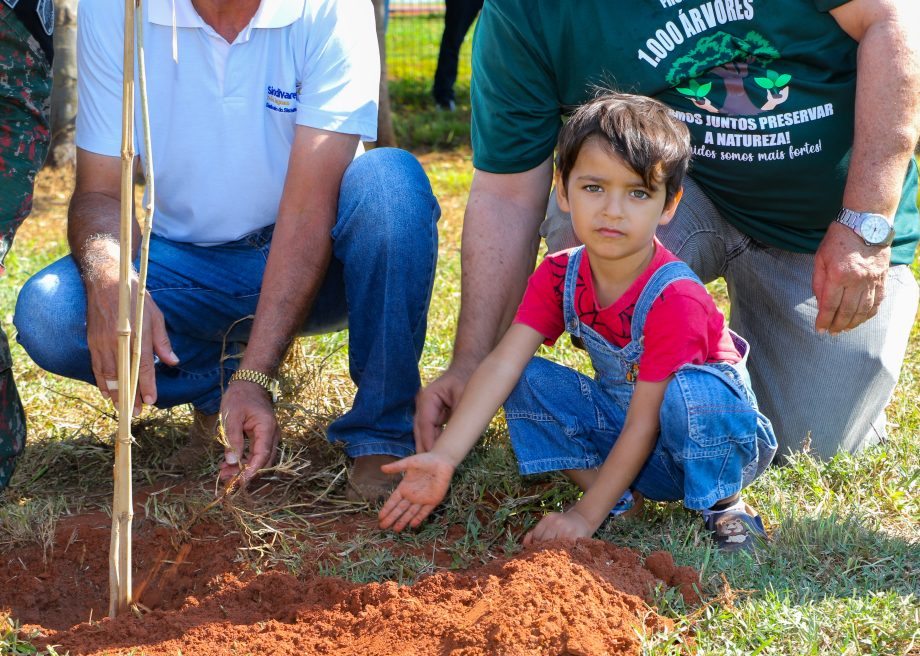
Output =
[{"x1": 811, "y1": 222, "x2": 891, "y2": 335}]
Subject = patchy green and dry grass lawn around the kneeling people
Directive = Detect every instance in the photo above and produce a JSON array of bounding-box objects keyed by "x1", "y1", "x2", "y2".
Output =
[{"x1": 0, "y1": 11, "x2": 920, "y2": 655}]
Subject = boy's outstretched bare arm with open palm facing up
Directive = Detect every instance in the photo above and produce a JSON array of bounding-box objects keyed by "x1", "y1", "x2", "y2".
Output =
[{"x1": 380, "y1": 324, "x2": 544, "y2": 531}]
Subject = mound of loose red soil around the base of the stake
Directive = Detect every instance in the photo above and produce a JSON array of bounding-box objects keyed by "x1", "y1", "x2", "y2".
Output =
[{"x1": 0, "y1": 515, "x2": 699, "y2": 656}]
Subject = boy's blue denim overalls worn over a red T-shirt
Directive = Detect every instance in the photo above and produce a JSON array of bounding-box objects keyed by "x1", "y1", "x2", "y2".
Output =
[{"x1": 505, "y1": 247, "x2": 776, "y2": 510}]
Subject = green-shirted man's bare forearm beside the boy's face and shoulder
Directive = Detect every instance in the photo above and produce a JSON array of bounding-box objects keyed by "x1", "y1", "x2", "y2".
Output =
[{"x1": 451, "y1": 160, "x2": 552, "y2": 377}]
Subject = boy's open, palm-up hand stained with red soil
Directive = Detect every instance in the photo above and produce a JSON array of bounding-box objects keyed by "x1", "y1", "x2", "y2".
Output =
[{"x1": 380, "y1": 452, "x2": 455, "y2": 533}]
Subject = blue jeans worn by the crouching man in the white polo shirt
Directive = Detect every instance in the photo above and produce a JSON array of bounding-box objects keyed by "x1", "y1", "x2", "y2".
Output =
[{"x1": 14, "y1": 148, "x2": 440, "y2": 457}]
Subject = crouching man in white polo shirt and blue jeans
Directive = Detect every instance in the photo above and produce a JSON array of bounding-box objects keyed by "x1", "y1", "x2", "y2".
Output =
[{"x1": 16, "y1": 0, "x2": 440, "y2": 498}]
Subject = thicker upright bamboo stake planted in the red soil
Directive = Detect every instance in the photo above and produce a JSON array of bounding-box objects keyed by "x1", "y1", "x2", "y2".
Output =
[{"x1": 109, "y1": 0, "x2": 135, "y2": 617}]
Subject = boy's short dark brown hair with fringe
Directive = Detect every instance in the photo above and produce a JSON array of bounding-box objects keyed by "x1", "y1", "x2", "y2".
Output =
[{"x1": 556, "y1": 93, "x2": 691, "y2": 202}]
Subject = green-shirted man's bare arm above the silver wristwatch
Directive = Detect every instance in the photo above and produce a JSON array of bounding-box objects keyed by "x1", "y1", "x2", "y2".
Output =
[{"x1": 835, "y1": 2, "x2": 920, "y2": 217}]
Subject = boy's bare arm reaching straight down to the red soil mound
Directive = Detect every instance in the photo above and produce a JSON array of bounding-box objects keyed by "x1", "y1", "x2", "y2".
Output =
[{"x1": 524, "y1": 376, "x2": 673, "y2": 545}]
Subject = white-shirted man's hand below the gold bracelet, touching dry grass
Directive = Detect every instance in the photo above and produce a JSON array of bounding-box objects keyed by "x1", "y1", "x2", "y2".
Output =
[{"x1": 220, "y1": 380, "x2": 281, "y2": 485}]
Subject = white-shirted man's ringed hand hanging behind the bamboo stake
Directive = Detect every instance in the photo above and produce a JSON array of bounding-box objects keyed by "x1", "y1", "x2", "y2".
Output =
[{"x1": 86, "y1": 275, "x2": 179, "y2": 415}]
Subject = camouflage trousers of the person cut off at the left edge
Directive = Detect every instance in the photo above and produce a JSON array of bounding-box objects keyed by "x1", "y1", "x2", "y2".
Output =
[{"x1": 0, "y1": 7, "x2": 51, "y2": 490}]
